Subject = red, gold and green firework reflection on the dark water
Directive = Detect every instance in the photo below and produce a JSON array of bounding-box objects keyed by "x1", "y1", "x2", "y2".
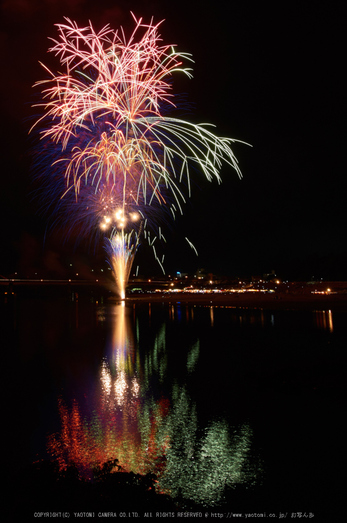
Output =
[{"x1": 48, "y1": 302, "x2": 256, "y2": 505}]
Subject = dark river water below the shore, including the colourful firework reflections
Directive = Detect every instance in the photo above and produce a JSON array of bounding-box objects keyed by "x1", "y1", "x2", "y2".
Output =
[{"x1": 0, "y1": 295, "x2": 347, "y2": 522}]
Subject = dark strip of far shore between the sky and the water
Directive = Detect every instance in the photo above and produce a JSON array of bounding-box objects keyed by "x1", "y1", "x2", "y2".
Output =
[{"x1": 0, "y1": 280, "x2": 347, "y2": 312}]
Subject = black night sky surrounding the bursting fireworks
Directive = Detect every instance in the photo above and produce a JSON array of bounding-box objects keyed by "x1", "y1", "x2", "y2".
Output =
[{"x1": 0, "y1": 0, "x2": 347, "y2": 279}]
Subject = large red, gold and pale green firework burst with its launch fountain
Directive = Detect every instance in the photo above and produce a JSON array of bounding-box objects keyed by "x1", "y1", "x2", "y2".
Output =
[{"x1": 35, "y1": 15, "x2": 245, "y2": 297}]
